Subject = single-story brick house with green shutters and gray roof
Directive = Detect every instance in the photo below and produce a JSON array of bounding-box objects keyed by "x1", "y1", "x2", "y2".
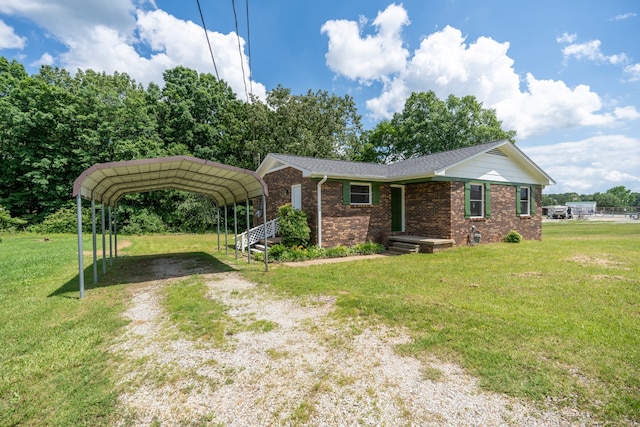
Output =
[{"x1": 254, "y1": 140, "x2": 555, "y2": 247}]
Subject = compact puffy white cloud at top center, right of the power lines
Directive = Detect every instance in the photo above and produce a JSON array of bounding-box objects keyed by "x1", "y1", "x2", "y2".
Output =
[{"x1": 321, "y1": 4, "x2": 409, "y2": 81}]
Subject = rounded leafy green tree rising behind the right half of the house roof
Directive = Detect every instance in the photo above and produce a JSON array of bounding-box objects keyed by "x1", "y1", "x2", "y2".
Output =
[{"x1": 360, "y1": 91, "x2": 516, "y2": 161}]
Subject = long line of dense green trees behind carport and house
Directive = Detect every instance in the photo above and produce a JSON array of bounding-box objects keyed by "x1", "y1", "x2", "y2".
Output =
[{"x1": 0, "y1": 57, "x2": 515, "y2": 232}]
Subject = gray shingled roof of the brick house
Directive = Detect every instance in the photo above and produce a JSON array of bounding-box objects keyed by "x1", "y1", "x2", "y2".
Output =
[{"x1": 262, "y1": 140, "x2": 507, "y2": 180}]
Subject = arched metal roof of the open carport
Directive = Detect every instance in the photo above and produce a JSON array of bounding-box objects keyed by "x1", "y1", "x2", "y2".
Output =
[{"x1": 73, "y1": 156, "x2": 268, "y2": 206}]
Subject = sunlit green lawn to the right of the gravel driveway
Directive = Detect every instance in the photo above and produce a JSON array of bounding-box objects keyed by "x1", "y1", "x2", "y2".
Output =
[{"x1": 252, "y1": 222, "x2": 640, "y2": 424}]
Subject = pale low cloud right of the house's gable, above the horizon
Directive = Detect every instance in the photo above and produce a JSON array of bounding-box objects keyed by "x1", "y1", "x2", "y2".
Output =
[{"x1": 520, "y1": 135, "x2": 640, "y2": 194}]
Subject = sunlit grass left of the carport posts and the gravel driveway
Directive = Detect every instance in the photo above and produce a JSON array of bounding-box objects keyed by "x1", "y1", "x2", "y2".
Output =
[{"x1": 0, "y1": 234, "x2": 129, "y2": 426}]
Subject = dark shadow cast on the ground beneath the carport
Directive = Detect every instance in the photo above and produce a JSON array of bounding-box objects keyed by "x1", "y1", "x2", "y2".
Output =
[{"x1": 48, "y1": 252, "x2": 236, "y2": 299}]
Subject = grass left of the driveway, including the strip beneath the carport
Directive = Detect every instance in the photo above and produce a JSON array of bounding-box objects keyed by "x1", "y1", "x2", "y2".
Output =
[{"x1": 0, "y1": 234, "x2": 233, "y2": 426}]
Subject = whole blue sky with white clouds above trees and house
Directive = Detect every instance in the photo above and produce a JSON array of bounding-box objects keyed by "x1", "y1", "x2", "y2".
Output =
[{"x1": 0, "y1": 0, "x2": 640, "y2": 193}]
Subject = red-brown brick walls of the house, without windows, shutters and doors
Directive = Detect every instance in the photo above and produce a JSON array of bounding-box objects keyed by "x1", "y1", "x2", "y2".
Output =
[{"x1": 256, "y1": 168, "x2": 542, "y2": 247}]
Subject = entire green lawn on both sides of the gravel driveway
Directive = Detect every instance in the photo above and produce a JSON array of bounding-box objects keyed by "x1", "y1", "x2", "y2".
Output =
[{"x1": 0, "y1": 226, "x2": 640, "y2": 426}]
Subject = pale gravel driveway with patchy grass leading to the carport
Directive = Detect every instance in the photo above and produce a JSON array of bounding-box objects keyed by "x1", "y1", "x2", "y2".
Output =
[{"x1": 113, "y1": 259, "x2": 589, "y2": 426}]
